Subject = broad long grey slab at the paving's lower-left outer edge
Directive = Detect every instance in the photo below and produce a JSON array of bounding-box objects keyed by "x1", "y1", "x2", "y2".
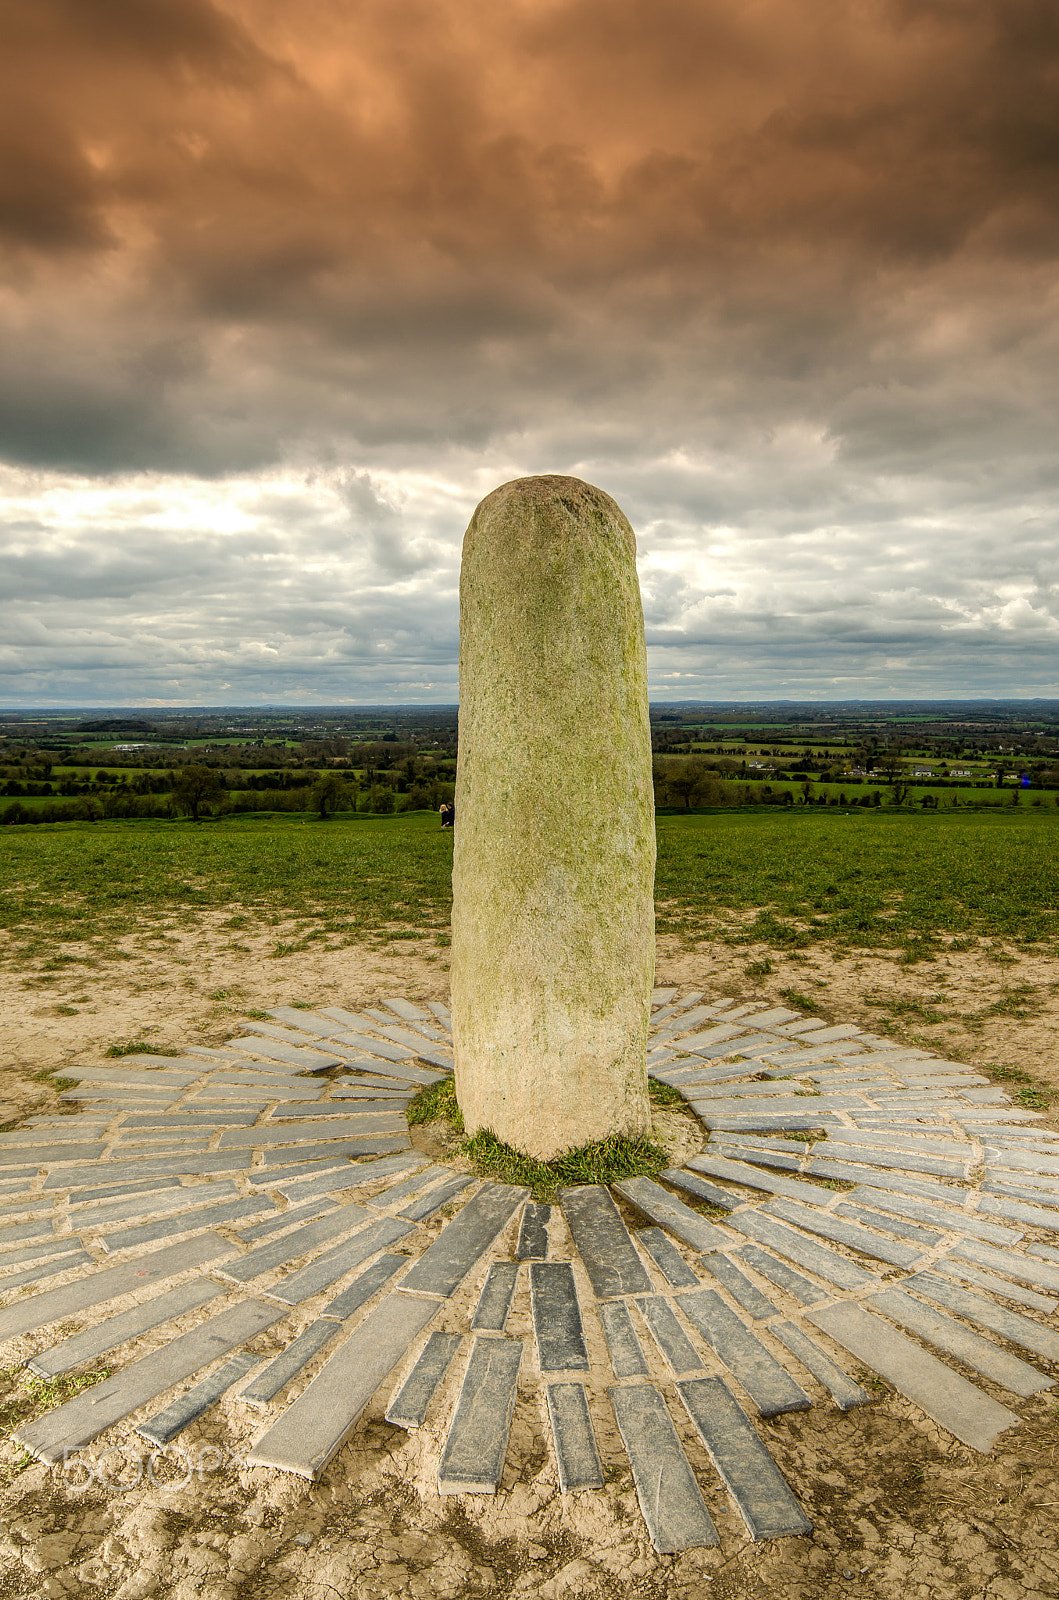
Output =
[{"x1": 248, "y1": 1294, "x2": 438, "y2": 1478}]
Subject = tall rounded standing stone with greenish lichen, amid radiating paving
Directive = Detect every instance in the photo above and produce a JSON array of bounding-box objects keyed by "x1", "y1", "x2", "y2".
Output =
[{"x1": 451, "y1": 477, "x2": 654, "y2": 1160}]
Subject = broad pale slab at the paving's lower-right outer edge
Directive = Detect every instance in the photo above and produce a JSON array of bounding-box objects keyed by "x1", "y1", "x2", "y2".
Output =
[{"x1": 806, "y1": 1301, "x2": 1017, "y2": 1453}]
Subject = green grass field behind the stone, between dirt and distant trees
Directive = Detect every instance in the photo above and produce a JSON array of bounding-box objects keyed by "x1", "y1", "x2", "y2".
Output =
[{"x1": 0, "y1": 806, "x2": 1059, "y2": 958}]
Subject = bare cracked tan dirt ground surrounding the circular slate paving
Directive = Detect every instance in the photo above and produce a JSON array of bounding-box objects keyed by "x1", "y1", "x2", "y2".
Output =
[{"x1": 0, "y1": 917, "x2": 1059, "y2": 1600}]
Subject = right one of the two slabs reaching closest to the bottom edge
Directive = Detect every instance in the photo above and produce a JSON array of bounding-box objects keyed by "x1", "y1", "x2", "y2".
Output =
[{"x1": 677, "y1": 1378, "x2": 813, "y2": 1539}]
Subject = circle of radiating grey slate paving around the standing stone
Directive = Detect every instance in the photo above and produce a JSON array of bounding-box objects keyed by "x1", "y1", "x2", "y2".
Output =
[{"x1": 8, "y1": 990, "x2": 1059, "y2": 1550}]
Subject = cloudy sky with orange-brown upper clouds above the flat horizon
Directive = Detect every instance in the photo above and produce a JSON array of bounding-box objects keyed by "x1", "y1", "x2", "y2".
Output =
[{"x1": 0, "y1": 0, "x2": 1059, "y2": 706}]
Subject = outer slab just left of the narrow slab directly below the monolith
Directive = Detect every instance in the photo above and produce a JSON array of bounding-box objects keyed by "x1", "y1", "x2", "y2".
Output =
[{"x1": 438, "y1": 1338, "x2": 522, "y2": 1494}]
